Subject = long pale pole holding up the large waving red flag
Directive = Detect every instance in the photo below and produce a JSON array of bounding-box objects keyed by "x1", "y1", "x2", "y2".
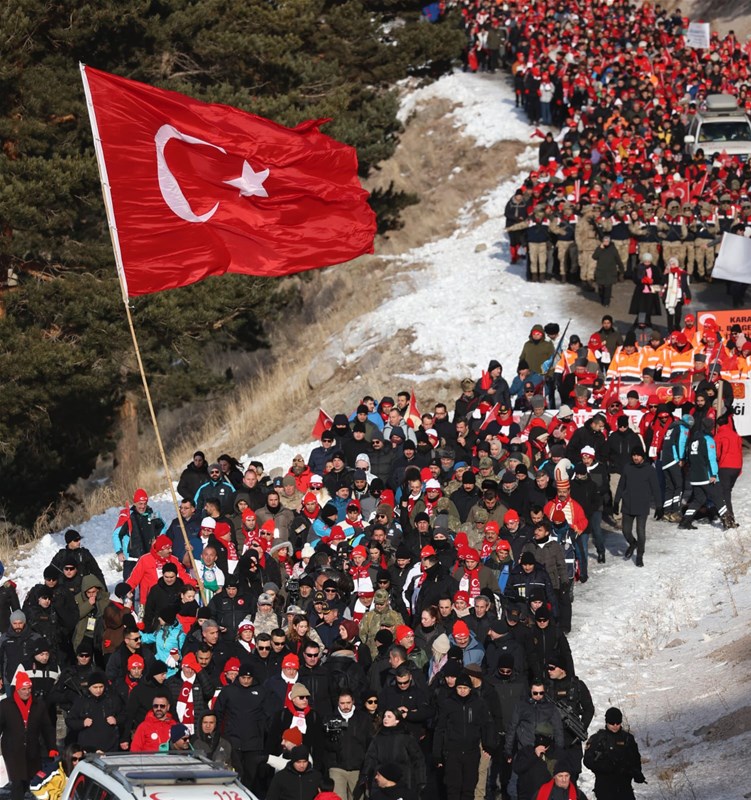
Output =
[{"x1": 79, "y1": 62, "x2": 208, "y2": 605}]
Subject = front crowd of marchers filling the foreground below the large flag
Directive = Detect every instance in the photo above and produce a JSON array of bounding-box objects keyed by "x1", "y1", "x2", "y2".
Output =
[{"x1": 0, "y1": 302, "x2": 745, "y2": 800}]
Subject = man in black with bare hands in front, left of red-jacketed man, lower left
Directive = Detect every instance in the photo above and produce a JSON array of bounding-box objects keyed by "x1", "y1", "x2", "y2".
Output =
[{"x1": 65, "y1": 672, "x2": 123, "y2": 753}]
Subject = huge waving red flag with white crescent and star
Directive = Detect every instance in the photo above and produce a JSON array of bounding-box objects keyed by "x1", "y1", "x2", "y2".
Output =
[{"x1": 81, "y1": 66, "x2": 375, "y2": 295}]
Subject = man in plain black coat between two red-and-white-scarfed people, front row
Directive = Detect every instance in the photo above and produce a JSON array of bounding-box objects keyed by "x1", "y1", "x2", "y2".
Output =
[{"x1": 214, "y1": 664, "x2": 270, "y2": 798}]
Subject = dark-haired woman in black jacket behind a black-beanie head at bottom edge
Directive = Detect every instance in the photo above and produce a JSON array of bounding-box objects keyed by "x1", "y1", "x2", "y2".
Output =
[{"x1": 359, "y1": 708, "x2": 427, "y2": 794}]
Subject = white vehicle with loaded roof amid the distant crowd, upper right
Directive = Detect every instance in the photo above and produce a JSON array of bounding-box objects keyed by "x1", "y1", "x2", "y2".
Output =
[{"x1": 684, "y1": 94, "x2": 751, "y2": 161}]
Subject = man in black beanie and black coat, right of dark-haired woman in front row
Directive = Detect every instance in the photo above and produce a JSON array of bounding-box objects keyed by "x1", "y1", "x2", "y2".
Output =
[{"x1": 433, "y1": 673, "x2": 496, "y2": 800}]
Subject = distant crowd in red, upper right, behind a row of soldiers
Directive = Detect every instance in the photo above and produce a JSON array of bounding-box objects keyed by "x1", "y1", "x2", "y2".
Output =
[{"x1": 445, "y1": 0, "x2": 751, "y2": 304}]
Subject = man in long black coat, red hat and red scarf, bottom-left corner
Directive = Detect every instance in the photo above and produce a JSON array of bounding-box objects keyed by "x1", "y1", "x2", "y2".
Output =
[{"x1": 0, "y1": 672, "x2": 57, "y2": 800}]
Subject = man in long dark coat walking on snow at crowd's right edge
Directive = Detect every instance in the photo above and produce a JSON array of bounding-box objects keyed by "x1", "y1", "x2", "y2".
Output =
[{"x1": 613, "y1": 447, "x2": 664, "y2": 567}]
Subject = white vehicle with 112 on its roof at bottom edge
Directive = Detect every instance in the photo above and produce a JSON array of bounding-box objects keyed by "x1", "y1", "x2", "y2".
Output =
[{"x1": 62, "y1": 753, "x2": 257, "y2": 800}]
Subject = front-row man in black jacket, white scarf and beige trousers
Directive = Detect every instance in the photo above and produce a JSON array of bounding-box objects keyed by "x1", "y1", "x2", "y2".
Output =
[{"x1": 323, "y1": 690, "x2": 373, "y2": 800}]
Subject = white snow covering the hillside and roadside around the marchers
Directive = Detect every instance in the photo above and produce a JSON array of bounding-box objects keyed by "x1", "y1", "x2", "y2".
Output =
[{"x1": 7, "y1": 73, "x2": 751, "y2": 800}]
